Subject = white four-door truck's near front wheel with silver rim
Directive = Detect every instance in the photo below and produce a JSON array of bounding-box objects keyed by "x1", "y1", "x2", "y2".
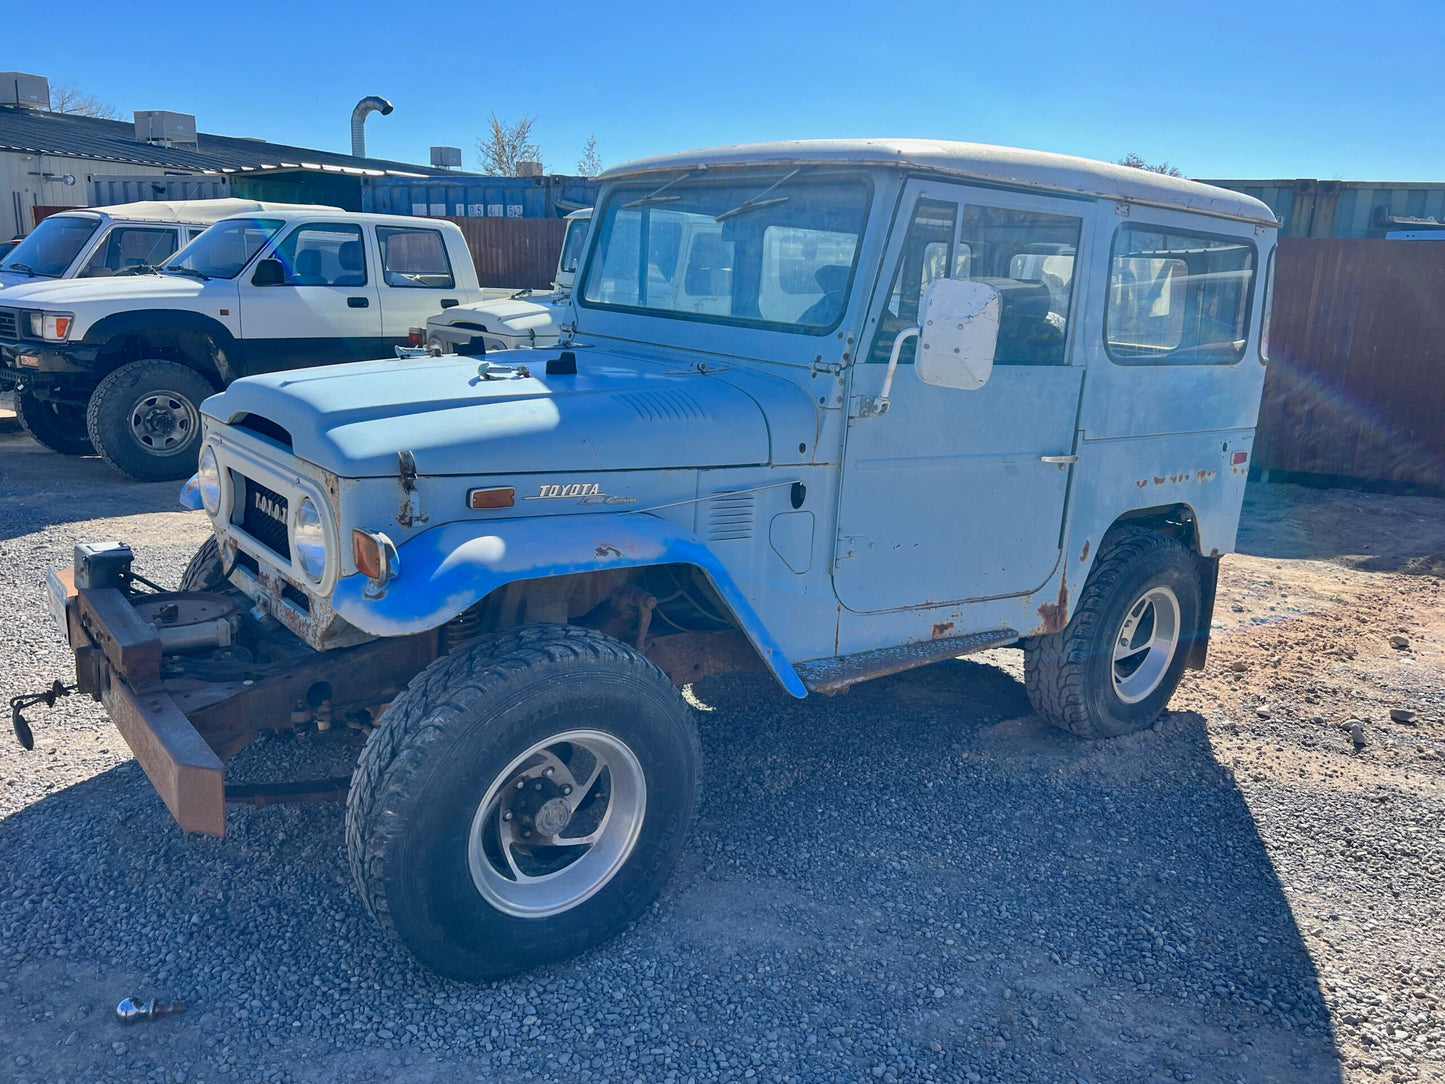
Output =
[{"x1": 85, "y1": 358, "x2": 215, "y2": 481}]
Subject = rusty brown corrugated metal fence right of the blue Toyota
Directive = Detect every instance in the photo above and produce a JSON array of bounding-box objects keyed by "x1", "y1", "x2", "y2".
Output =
[{"x1": 1254, "y1": 238, "x2": 1445, "y2": 493}]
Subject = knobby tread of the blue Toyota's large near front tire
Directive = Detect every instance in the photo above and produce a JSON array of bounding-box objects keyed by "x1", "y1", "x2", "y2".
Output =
[{"x1": 347, "y1": 624, "x2": 702, "y2": 939}]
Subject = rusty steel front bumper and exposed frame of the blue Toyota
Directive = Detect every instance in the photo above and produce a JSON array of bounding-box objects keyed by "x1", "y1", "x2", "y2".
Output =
[{"x1": 49, "y1": 568, "x2": 438, "y2": 835}]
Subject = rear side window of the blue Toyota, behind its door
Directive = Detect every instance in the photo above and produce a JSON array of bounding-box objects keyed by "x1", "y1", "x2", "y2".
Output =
[{"x1": 1104, "y1": 225, "x2": 1257, "y2": 366}]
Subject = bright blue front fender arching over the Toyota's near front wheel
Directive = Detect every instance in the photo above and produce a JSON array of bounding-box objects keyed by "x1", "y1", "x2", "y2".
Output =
[{"x1": 331, "y1": 513, "x2": 808, "y2": 698}]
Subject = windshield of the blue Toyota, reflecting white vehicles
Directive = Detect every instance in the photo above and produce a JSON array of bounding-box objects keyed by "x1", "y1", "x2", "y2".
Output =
[{"x1": 582, "y1": 169, "x2": 870, "y2": 334}]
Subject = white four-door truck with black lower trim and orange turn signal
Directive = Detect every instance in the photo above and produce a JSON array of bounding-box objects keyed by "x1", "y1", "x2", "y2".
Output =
[{"x1": 0, "y1": 207, "x2": 483, "y2": 481}]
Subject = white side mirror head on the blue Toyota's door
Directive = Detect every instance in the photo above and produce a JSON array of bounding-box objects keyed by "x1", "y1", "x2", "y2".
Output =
[{"x1": 913, "y1": 279, "x2": 1003, "y2": 392}]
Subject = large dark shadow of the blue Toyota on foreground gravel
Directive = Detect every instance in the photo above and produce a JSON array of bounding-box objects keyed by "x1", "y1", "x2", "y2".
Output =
[{"x1": 0, "y1": 661, "x2": 1340, "y2": 1084}]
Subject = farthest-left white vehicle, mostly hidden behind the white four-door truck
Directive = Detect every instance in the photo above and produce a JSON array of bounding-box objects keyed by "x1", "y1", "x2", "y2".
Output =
[{"x1": 0, "y1": 199, "x2": 313, "y2": 288}]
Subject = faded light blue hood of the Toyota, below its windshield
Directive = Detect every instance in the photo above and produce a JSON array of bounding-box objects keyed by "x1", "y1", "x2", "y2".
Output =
[{"x1": 202, "y1": 350, "x2": 811, "y2": 477}]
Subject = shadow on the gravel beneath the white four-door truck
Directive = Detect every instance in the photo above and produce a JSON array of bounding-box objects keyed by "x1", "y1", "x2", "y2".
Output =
[{"x1": 0, "y1": 434, "x2": 197, "y2": 541}]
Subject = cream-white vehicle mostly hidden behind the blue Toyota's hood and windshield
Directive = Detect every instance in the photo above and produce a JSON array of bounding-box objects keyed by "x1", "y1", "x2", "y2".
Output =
[{"x1": 426, "y1": 207, "x2": 592, "y2": 354}]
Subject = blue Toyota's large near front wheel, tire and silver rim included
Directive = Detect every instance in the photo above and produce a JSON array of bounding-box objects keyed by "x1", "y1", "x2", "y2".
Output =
[{"x1": 347, "y1": 624, "x2": 701, "y2": 981}]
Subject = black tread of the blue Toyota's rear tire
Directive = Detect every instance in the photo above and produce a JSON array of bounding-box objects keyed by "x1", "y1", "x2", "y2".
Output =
[{"x1": 1023, "y1": 528, "x2": 1188, "y2": 739}]
